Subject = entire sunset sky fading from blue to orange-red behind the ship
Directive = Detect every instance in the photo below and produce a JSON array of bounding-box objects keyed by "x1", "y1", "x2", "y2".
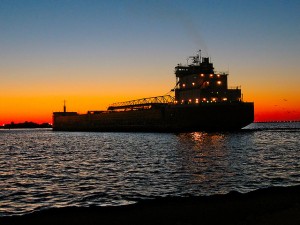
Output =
[{"x1": 0, "y1": 0, "x2": 300, "y2": 124}]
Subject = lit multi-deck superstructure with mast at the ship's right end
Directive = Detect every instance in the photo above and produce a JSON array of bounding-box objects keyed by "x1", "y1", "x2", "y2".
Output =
[{"x1": 175, "y1": 51, "x2": 242, "y2": 104}]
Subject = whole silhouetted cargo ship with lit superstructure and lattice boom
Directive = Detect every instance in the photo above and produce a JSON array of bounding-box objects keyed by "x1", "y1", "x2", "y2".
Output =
[{"x1": 53, "y1": 51, "x2": 254, "y2": 132}]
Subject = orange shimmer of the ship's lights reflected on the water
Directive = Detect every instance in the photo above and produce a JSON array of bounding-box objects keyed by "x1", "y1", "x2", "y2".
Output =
[{"x1": 177, "y1": 132, "x2": 230, "y2": 186}]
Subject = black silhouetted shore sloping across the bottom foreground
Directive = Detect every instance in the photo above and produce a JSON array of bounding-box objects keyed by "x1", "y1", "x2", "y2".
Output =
[{"x1": 0, "y1": 186, "x2": 300, "y2": 225}]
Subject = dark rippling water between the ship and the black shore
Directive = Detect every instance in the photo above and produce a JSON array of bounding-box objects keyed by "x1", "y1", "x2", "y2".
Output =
[{"x1": 0, "y1": 123, "x2": 300, "y2": 216}]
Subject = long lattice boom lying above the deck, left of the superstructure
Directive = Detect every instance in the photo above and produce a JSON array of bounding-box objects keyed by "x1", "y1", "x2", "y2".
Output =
[{"x1": 108, "y1": 95, "x2": 175, "y2": 109}]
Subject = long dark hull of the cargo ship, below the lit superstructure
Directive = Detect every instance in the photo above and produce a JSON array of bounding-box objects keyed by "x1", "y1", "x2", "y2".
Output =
[{"x1": 53, "y1": 102, "x2": 254, "y2": 132}]
